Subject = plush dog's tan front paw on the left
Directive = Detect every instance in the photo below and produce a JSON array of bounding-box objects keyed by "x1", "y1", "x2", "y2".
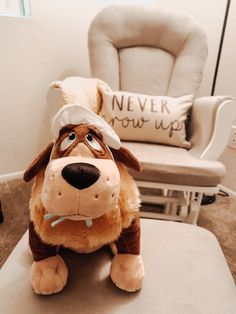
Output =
[{"x1": 31, "y1": 255, "x2": 68, "y2": 294}]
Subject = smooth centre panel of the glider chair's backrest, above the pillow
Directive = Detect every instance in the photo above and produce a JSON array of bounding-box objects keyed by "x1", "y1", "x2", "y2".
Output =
[{"x1": 119, "y1": 46, "x2": 175, "y2": 96}]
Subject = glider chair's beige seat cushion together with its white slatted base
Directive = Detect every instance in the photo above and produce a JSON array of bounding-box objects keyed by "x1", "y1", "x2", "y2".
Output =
[{"x1": 122, "y1": 141, "x2": 225, "y2": 224}]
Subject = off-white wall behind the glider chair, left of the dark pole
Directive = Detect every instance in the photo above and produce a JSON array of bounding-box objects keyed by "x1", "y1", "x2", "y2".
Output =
[{"x1": 0, "y1": 0, "x2": 234, "y2": 193}]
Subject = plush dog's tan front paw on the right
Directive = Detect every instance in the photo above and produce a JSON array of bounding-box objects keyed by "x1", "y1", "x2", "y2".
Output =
[{"x1": 110, "y1": 254, "x2": 144, "y2": 292}]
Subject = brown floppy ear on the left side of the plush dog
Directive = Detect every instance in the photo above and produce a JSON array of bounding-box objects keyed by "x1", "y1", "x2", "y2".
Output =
[{"x1": 23, "y1": 142, "x2": 53, "y2": 182}]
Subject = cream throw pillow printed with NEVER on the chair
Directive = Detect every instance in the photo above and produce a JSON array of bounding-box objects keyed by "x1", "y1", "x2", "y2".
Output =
[{"x1": 98, "y1": 84, "x2": 193, "y2": 148}]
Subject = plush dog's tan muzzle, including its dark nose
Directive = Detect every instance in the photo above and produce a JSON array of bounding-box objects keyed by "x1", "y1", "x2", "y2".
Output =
[{"x1": 41, "y1": 157, "x2": 120, "y2": 221}]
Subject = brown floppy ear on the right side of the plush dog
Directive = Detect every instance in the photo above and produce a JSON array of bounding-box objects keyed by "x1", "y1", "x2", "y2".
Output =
[{"x1": 110, "y1": 147, "x2": 141, "y2": 171}]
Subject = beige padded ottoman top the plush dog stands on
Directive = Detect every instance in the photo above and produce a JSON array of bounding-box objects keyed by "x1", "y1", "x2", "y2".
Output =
[{"x1": 0, "y1": 220, "x2": 236, "y2": 314}]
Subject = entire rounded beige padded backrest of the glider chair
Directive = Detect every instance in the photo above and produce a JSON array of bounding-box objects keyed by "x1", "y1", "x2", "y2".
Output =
[{"x1": 88, "y1": 5, "x2": 207, "y2": 96}]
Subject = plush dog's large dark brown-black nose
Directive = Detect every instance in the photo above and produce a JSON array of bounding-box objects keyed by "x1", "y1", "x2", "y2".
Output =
[{"x1": 61, "y1": 162, "x2": 100, "y2": 190}]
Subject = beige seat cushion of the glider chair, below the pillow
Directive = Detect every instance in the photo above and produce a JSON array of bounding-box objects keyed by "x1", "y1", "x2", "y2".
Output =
[{"x1": 122, "y1": 142, "x2": 225, "y2": 187}]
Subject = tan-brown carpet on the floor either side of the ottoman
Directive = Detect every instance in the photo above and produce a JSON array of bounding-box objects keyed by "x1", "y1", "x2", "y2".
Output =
[{"x1": 0, "y1": 180, "x2": 236, "y2": 282}]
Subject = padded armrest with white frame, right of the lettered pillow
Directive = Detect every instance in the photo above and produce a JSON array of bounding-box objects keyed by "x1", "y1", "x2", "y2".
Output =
[{"x1": 189, "y1": 96, "x2": 236, "y2": 160}]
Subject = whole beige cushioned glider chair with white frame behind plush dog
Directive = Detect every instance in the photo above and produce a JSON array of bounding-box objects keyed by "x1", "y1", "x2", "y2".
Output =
[{"x1": 88, "y1": 6, "x2": 236, "y2": 223}]
